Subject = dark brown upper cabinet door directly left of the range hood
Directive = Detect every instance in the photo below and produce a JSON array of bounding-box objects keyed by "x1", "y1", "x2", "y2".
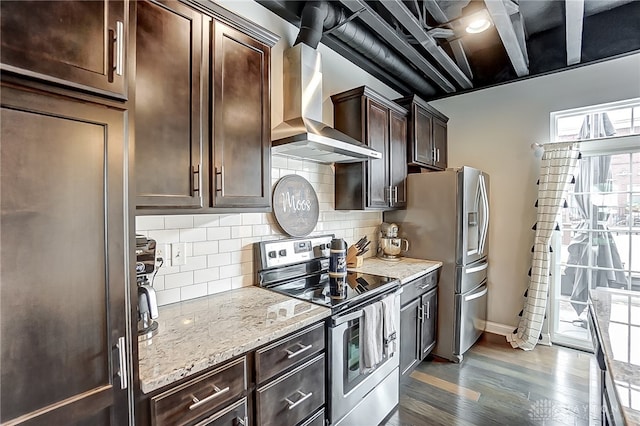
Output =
[{"x1": 210, "y1": 22, "x2": 271, "y2": 208}]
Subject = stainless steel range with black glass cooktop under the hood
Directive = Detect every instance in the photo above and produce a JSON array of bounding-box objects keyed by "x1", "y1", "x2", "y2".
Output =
[{"x1": 255, "y1": 235, "x2": 401, "y2": 425}]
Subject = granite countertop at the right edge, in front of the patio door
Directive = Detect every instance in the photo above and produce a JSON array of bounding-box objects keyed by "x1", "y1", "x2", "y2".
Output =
[{"x1": 589, "y1": 288, "x2": 640, "y2": 425}]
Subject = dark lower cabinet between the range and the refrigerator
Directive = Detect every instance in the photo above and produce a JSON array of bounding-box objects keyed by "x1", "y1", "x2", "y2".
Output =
[{"x1": 400, "y1": 271, "x2": 438, "y2": 380}]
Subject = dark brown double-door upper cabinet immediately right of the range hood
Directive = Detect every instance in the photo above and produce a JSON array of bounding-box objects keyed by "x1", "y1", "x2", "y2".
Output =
[{"x1": 331, "y1": 86, "x2": 407, "y2": 210}]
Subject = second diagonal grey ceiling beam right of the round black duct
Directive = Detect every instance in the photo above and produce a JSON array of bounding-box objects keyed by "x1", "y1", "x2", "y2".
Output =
[{"x1": 380, "y1": 0, "x2": 473, "y2": 89}]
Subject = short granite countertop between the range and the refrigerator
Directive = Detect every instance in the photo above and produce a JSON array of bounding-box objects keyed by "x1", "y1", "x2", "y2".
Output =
[{"x1": 349, "y1": 257, "x2": 442, "y2": 284}]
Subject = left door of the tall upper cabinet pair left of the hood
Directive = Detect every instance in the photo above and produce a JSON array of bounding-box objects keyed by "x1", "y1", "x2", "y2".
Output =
[{"x1": 135, "y1": 1, "x2": 211, "y2": 208}]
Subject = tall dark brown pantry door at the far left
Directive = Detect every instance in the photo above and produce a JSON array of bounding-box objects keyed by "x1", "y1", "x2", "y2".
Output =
[{"x1": 0, "y1": 83, "x2": 132, "y2": 426}]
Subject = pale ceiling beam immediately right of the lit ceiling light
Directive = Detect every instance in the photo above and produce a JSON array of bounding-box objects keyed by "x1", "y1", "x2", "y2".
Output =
[{"x1": 484, "y1": 0, "x2": 529, "y2": 77}]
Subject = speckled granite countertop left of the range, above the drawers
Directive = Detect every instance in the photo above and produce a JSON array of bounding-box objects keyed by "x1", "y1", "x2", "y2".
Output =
[{"x1": 138, "y1": 287, "x2": 331, "y2": 393}]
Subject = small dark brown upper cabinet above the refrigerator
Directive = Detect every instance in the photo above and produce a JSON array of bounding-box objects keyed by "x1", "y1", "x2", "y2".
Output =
[{"x1": 396, "y1": 95, "x2": 449, "y2": 170}]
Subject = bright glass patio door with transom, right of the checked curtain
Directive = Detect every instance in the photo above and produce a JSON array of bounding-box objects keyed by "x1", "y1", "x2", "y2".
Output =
[{"x1": 550, "y1": 98, "x2": 640, "y2": 347}]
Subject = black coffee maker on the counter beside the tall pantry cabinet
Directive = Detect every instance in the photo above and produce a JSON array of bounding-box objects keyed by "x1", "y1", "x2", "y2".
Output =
[{"x1": 136, "y1": 235, "x2": 158, "y2": 340}]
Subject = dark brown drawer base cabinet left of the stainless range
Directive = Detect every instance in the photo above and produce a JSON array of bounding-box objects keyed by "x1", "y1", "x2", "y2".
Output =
[{"x1": 144, "y1": 322, "x2": 326, "y2": 426}]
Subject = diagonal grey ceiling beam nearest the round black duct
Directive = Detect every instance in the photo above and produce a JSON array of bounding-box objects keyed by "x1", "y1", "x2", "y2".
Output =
[{"x1": 340, "y1": 0, "x2": 456, "y2": 93}]
